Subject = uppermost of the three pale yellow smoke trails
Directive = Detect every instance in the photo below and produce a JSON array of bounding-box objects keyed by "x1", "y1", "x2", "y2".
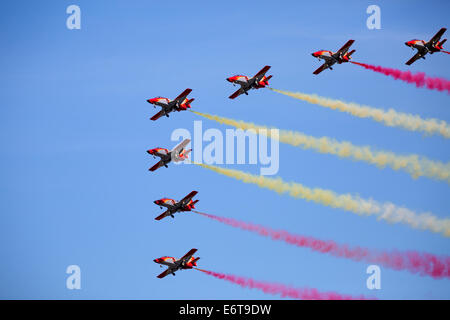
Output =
[{"x1": 269, "y1": 88, "x2": 450, "y2": 138}]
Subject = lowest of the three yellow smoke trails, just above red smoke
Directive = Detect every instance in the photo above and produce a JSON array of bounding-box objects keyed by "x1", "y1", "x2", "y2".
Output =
[{"x1": 195, "y1": 163, "x2": 450, "y2": 237}]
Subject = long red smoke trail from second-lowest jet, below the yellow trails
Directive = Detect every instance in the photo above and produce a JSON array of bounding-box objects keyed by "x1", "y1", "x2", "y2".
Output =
[{"x1": 194, "y1": 211, "x2": 450, "y2": 279}]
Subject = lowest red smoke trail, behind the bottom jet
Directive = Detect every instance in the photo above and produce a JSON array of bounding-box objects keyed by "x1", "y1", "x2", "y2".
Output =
[{"x1": 195, "y1": 268, "x2": 373, "y2": 300}]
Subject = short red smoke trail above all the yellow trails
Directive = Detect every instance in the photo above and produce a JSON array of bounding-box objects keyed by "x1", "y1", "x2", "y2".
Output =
[{"x1": 350, "y1": 61, "x2": 450, "y2": 93}]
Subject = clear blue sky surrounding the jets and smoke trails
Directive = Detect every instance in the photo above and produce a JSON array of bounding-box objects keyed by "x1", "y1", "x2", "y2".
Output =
[{"x1": 0, "y1": 1, "x2": 450, "y2": 299}]
